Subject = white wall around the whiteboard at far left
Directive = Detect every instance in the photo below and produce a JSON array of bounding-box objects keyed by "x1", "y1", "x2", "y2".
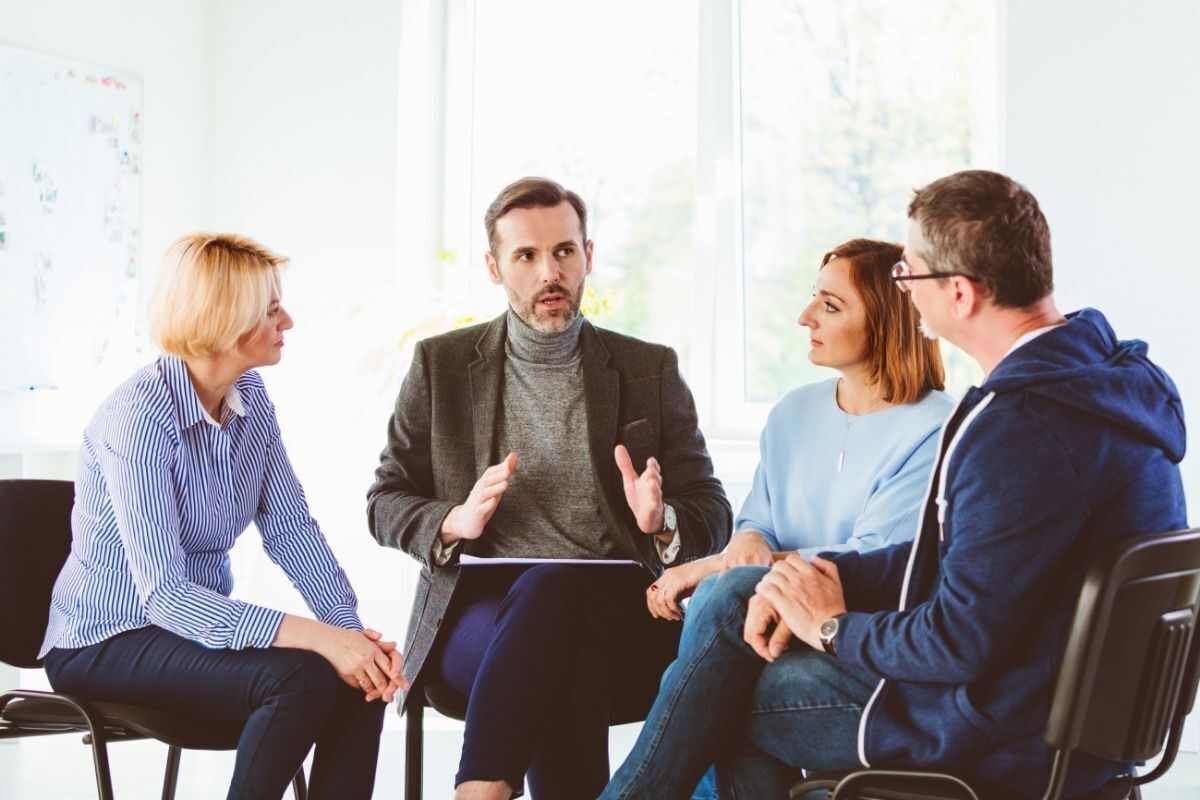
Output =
[{"x1": 0, "y1": 0, "x2": 215, "y2": 687}]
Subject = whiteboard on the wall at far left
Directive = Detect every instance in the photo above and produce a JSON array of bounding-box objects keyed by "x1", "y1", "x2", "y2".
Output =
[{"x1": 0, "y1": 46, "x2": 143, "y2": 392}]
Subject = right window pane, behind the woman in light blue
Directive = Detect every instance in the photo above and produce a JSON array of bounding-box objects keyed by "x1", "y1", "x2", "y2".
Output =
[{"x1": 740, "y1": 0, "x2": 997, "y2": 402}]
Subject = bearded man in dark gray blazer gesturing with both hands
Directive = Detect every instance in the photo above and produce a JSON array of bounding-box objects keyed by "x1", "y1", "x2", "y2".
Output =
[{"x1": 368, "y1": 178, "x2": 732, "y2": 800}]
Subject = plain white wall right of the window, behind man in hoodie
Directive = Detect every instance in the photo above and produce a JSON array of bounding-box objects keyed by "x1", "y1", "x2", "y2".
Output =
[{"x1": 1004, "y1": 0, "x2": 1200, "y2": 751}]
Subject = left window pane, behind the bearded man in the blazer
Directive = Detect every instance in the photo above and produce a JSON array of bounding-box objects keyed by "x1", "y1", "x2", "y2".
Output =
[{"x1": 460, "y1": 0, "x2": 697, "y2": 363}]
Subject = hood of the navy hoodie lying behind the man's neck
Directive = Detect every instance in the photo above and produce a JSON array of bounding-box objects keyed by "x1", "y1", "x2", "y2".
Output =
[{"x1": 979, "y1": 308, "x2": 1187, "y2": 464}]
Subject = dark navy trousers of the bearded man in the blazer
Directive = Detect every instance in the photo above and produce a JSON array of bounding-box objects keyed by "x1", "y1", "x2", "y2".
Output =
[{"x1": 433, "y1": 565, "x2": 682, "y2": 800}]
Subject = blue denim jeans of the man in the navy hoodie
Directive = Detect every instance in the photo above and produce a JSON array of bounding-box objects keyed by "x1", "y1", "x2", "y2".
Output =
[{"x1": 600, "y1": 567, "x2": 878, "y2": 800}]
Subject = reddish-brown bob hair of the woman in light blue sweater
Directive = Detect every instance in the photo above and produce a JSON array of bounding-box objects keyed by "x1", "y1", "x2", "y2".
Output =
[{"x1": 821, "y1": 239, "x2": 946, "y2": 404}]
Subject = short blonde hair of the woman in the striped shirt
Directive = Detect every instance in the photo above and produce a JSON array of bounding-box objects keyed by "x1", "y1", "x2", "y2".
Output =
[{"x1": 150, "y1": 233, "x2": 288, "y2": 357}]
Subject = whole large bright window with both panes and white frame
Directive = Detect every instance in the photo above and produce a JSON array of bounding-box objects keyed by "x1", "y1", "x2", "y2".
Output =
[{"x1": 432, "y1": 0, "x2": 1000, "y2": 438}]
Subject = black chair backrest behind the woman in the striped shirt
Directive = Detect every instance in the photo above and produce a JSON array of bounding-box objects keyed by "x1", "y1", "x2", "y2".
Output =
[{"x1": 0, "y1": 480, "x2": 74, "y2": 668}]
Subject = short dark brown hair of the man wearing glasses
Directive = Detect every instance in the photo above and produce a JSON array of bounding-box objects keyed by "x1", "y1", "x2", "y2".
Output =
[{"x1": 908, "y1": 169, "x2": 1054, "y2": 308}]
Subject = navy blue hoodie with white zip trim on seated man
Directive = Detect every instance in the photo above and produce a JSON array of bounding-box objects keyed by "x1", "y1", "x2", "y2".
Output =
[{"x1": 835, "y1": 308, "x2": 1187, "y2": 796}]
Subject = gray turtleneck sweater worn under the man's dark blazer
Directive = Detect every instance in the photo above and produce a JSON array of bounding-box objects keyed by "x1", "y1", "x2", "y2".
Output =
[{"x1": 465, "y1": 309, "x2": 619, "y2": 558}]
